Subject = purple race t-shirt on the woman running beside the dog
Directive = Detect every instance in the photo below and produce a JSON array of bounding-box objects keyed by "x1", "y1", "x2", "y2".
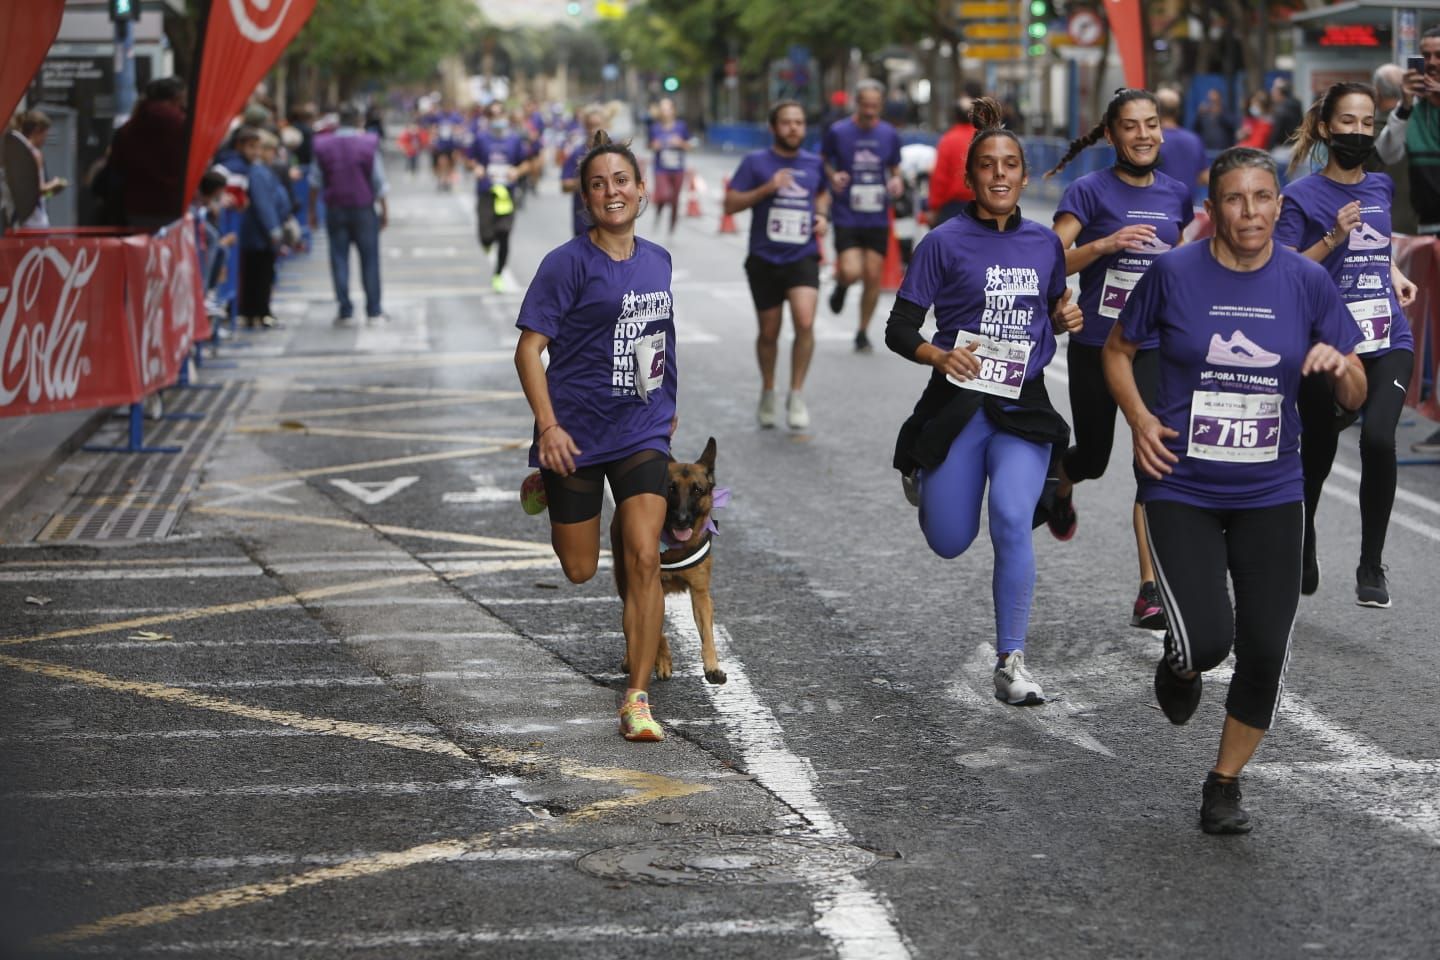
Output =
[{"x1": 516, "y1": 235, "x2": 680, "y2": 466}]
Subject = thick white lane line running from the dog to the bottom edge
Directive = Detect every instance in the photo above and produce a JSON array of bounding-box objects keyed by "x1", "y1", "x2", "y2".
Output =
[{"x1": 661, "y1": 593, "x2": 910, "y2": 960}]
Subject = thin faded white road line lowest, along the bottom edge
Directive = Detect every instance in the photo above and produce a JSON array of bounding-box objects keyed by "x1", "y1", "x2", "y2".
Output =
[{"x1": 56, "y1": 917, "x2": 817, "y2": 957}]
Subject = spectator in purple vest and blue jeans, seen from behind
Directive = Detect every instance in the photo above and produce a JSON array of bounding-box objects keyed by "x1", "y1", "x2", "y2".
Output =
[{"x1": 310, "y1": 104, "x2": 389, "y2": 327}]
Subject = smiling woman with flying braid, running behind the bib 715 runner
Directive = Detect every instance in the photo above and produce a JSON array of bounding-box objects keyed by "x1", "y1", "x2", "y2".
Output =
[{"x1": 1045, "y1": 89, "x2": 1195, "y2": 630}]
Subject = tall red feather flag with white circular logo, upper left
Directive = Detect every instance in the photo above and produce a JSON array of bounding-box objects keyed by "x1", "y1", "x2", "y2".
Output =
[{"x1": 183, "y1": 0, "x2": 315, "y2": 203}]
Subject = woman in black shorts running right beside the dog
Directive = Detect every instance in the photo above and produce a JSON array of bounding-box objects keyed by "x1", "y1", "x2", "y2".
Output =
[{"x1": 516, "y1": 131, "x2": 677, "y2": 740}]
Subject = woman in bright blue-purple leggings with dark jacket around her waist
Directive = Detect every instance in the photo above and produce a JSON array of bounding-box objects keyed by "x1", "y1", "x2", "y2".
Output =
[{"x1": 886, "y1": 98, "x2": 1081, "y2": 705}]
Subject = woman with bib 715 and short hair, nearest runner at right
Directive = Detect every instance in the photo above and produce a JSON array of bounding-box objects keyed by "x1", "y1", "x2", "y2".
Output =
[{"x1": 1104, "y1": 147, "x2": 1365, "y2": 833}]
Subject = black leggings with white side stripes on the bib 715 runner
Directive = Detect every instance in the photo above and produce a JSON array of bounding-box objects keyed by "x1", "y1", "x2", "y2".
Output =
[{"x1": 1145, "y1": 499, "x2": 1305, "y2": 730}]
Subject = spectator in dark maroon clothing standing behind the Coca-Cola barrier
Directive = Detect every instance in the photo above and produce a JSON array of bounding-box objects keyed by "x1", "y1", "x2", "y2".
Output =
[{"x1": 108, "y1": 76, "x2": 189, "y2": 232}]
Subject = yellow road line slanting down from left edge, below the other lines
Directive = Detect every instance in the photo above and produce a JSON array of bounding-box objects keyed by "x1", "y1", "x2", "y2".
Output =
[{"x1": 0, "y1": 653, "x2": 474, "y2": 760}]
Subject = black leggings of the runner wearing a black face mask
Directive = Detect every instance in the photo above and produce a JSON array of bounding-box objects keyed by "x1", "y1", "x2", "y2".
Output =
[{"x1": 1299, "y1": 350, "x2": 1416, "y2": 564}]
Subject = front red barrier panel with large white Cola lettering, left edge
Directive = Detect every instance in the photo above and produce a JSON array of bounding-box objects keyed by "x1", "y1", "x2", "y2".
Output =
[{"x1": 0, "y1": 237, "x2": 144, "y2": 416}]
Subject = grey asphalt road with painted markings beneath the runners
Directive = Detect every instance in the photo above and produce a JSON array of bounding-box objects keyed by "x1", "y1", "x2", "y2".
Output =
[{"x1": 0, "y1": 144, "x2": 1440, "y2": 959}]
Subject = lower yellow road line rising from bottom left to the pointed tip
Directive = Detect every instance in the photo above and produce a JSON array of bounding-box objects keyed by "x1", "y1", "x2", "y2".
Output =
[{"x1": 29, "y1": 771, "x2": 713, "y2": 950}]
